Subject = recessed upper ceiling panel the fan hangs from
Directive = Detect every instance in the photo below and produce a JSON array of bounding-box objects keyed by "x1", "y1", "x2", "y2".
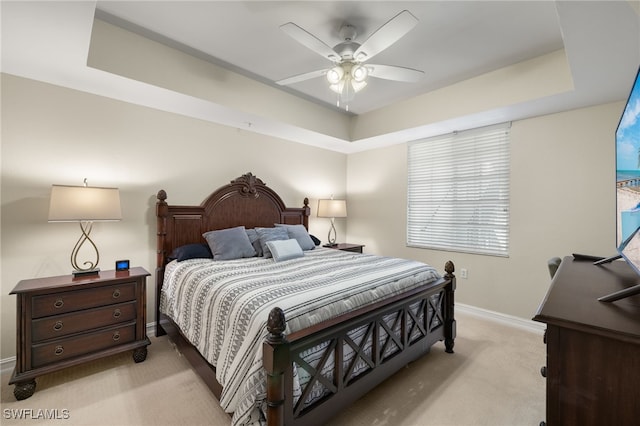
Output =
[{"x1": 98, "y1": 1, "x2": 563, "y2": 114}]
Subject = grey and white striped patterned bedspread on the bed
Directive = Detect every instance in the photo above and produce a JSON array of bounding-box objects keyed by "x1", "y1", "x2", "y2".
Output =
[{"x1": 160, "y1": 248, "x2": 440, "y2": 425}]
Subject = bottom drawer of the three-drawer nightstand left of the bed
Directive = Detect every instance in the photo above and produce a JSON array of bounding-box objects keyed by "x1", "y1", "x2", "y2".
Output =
[{"x1": 31, "y1": 323, "x2": 136, "y2": 368}]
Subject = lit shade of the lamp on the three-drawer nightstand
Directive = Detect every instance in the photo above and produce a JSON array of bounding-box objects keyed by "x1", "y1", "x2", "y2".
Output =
[{"x1": 49, "y1": 185, "x2": 122, "y2": 222}]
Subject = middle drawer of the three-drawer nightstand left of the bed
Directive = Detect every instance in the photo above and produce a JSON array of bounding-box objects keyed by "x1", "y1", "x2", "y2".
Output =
[{"x1": 31, "y1": 302, "x2": 136, "y2": 342}]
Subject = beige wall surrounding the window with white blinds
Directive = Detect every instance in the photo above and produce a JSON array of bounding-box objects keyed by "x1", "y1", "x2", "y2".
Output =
[{"x1": 347, "y1": 102, "x2": 623, "y2": 319}]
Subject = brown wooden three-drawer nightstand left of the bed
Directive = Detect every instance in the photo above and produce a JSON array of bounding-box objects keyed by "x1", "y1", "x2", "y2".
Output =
[{"x1": 9, "y1": 267, "x2": 151, "y2": 400}]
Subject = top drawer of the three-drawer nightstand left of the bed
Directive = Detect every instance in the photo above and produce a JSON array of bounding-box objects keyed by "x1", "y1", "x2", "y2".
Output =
[{"x1": 31, "y1": 282, "x2": 136, "y2": 318}]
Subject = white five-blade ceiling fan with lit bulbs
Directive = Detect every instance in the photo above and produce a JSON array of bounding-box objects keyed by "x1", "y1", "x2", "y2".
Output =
[{"x1": 276, "y1": 10, "x2": 424, "y2": 109}]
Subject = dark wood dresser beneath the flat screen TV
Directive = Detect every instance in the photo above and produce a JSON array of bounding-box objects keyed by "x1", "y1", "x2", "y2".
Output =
[{"x1": 533, "y1": 256, "x2": 640, "y2": 426}]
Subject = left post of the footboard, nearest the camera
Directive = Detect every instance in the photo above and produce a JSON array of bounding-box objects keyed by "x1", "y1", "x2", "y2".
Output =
[{"x1": 262, "y1": 307, "x2": 290, "y2": 426}]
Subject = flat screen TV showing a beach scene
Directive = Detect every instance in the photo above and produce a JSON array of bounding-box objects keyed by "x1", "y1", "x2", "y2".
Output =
[{"x1": 599, "y1": 65, "x2": 640, "y2": 302}]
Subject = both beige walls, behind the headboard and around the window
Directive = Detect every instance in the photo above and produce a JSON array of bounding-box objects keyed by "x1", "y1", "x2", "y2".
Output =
[{"x1": 0, "y1": 75, "x2": 623, "y2": 359}]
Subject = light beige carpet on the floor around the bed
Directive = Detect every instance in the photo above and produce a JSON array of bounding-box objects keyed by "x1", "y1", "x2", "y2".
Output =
[{"x1": 0, "y1": 313, "x2": 545, "y2": 426}]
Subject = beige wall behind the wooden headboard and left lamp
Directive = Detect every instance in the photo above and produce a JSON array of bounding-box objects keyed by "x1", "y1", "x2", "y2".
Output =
[{"x1": 0, "y1": 75, "x2": 346, "y2": 359}]
